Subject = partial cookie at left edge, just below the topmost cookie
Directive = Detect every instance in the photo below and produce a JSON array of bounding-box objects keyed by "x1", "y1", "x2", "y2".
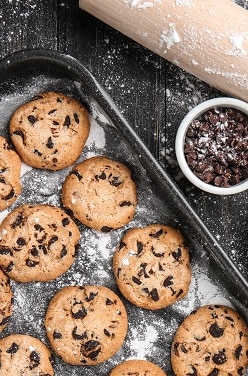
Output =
[{"x1": 0, "y1": 136, "x2": 22, "y2": 210}]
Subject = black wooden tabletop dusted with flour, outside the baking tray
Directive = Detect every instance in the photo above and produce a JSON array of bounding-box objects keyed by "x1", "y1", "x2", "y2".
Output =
[{"x1": 0, "y1": 0, "x2": 248, "y2": 322}]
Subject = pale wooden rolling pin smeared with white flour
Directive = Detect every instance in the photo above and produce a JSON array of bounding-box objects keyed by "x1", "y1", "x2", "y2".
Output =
[{"x1": 79, "y1": 0, "x2": 248, "y2": 101}]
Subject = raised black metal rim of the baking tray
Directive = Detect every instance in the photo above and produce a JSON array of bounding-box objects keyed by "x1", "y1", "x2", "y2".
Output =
[{"x1": 0, "y1": 48, "x2": 248, "y2": 306}]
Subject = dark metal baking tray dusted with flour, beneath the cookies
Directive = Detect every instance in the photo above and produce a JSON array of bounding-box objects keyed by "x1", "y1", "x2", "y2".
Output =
[{"x1": 0, "y1": 50, "x2": 248, "y2": 376}]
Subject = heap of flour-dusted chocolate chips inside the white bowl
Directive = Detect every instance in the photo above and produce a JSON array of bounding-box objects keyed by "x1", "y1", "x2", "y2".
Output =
[{"x1": 184, "y1": 108, "x2": 248, "y2": 187}]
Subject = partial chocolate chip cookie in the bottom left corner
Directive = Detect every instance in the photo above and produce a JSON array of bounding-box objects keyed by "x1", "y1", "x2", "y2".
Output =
[{"x1": 0, "y1": 334, "x2": 54, "y2": 376}]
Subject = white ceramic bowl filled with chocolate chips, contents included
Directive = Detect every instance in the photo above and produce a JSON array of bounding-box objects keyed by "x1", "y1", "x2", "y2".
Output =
[{"x1": 175, "y1": 97, "x2": 248, "y2": 195}]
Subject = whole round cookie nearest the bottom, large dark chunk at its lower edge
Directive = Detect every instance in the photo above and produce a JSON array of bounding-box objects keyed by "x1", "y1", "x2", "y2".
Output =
[{"x1": 45, "y1": 286, "x2": 128, "y2": 366}]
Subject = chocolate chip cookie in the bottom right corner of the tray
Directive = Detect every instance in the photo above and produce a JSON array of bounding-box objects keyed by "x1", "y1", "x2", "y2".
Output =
[{"x1": 171, "y1": 305, "x2": 248, "y2": 376}]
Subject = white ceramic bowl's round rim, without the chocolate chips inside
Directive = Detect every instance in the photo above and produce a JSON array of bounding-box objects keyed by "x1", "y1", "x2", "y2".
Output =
[{"x1": 175, "y1": 97, "x2": 248, "y2": 195}]
